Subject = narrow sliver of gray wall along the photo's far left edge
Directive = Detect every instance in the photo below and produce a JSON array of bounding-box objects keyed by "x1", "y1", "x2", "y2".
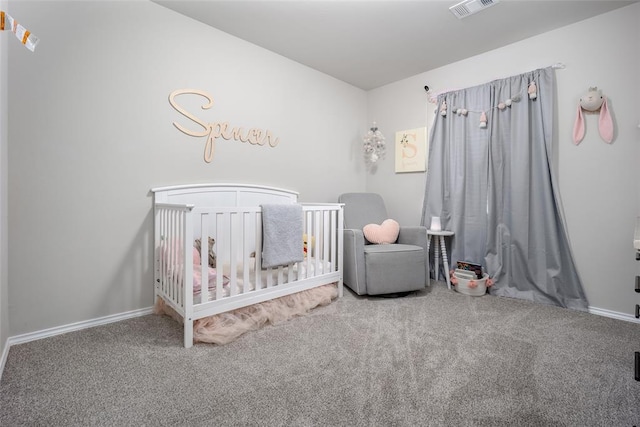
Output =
[{"x1": 0, "y1": 0, "x2": 9, "y2": 362}]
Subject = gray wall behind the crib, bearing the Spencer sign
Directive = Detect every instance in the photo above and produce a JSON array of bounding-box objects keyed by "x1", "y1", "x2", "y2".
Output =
[{"x1": 3, "y1": 1, "x2": 366, "y2": 336}]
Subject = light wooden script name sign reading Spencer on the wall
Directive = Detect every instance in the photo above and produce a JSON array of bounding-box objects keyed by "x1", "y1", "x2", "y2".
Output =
[{"x1": 169, "y1": 89, "x2": 280, "y2": 163}]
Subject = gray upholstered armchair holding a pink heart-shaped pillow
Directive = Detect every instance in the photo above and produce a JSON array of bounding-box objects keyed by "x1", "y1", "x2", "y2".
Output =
[{"x1": 338, "y1": 193, "x2": 429, "y2": 295}]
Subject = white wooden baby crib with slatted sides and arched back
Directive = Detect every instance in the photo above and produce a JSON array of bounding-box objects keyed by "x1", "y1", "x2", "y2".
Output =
[{"x1": 151, "y1": 184, "x2": 343, "y2": 348}]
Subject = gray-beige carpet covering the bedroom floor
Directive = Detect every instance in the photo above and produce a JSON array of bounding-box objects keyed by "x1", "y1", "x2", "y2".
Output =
[{"x1": 0, "y1": 283, "x2": 640, "y2": 427}]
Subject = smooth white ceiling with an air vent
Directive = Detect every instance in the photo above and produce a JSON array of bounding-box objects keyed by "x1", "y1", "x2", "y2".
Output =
[{"x1": 152, "y1": 0, "x2": 637, "y2": 90}]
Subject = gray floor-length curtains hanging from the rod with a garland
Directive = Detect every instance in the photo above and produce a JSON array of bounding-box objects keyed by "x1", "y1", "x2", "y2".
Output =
[{"x1": 422, "y1": 67, "x2": 588, "y2": 310}]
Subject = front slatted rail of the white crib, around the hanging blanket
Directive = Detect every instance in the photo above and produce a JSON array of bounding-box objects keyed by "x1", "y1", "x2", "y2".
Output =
[{"x1": 193, "y1": 204, "x2": 342, "y2": 302}]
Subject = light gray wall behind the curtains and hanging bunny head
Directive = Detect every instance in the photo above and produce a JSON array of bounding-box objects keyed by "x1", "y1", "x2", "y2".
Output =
[{"x1": 367, "y1": 4, "x2": 640, "y2": 314}]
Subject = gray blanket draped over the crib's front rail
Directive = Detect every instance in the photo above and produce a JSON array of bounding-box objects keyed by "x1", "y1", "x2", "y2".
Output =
[{"x1": 261, "y1": 204, "x2": 304, "y2": 268}]
